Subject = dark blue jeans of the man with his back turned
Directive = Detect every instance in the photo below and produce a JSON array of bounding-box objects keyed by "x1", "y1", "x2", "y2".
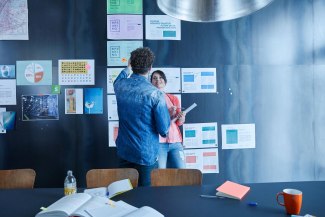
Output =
[{"x1": 119, "y1": 158, "x2": 158, "y2": 186}]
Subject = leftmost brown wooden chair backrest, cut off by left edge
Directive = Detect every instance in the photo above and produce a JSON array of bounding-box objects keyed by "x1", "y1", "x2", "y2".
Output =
[{"x1": 0, "y1": 169, "x2": 36, "y2": 189}]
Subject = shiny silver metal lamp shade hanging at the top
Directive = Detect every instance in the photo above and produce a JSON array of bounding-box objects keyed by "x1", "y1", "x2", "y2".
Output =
[{"x1": 157, "y1": 0, "x2": 273, "y2": 22}]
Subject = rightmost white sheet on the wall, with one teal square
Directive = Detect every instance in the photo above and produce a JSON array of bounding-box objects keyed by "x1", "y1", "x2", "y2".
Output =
[{"x1": 221, "y1": 124, "x2": 255, "y2": 149}]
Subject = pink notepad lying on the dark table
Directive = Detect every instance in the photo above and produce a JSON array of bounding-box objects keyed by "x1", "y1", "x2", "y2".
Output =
[{"x1": 216, "y1": 181, "x2": 250, "y2": 200}]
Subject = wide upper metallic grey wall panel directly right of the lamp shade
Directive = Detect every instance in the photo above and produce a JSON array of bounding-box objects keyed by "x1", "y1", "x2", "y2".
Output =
[{"x1": 237, "y1": 0, "x2": 313, "y2": 65}]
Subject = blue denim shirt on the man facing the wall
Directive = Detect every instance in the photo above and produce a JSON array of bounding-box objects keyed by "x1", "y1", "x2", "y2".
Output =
[{"x1": 114, "y1": 68, "x2": 170, "y2": 166}]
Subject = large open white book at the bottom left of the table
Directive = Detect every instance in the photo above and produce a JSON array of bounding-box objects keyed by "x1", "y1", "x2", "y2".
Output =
[{"x1": 36, "y1": 193, "x2": 109, "y2": 217}]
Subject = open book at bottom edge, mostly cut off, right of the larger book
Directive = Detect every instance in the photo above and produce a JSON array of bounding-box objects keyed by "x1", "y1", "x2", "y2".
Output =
[{"x1": 85, "y1": 200, "x2": 163, "y2": 217}]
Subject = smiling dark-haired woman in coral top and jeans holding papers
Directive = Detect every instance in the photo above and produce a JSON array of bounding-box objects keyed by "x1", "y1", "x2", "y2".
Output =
[{"x1": 150, "y1": 70, "x2": 185, "y2": 168}]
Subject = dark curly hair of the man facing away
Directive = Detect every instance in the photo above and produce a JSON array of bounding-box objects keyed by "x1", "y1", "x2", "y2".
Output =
[{"x1": 130, "y1": 47, "x2": 155, "y2": 74}]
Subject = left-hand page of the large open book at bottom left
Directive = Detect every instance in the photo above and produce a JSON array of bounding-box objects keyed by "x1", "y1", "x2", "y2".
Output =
[{"x1": 36, "y1": 193, "x2": 91, "y2": 217}]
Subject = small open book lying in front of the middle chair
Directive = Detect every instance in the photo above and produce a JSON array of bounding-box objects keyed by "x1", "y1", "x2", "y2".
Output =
[{"x1": 84, "y1": 179, "x2": 133, "y2": 198}]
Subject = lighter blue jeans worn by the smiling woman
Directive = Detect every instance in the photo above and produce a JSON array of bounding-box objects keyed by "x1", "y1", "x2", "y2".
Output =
[{"x1": 158, "y1": 142, "x2": 185, "y2": 169}]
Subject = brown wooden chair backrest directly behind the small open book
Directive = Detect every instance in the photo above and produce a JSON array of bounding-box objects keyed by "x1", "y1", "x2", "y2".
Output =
[{"x1": 86, "y1": 168, "x2": 139, "y2": 188}]
